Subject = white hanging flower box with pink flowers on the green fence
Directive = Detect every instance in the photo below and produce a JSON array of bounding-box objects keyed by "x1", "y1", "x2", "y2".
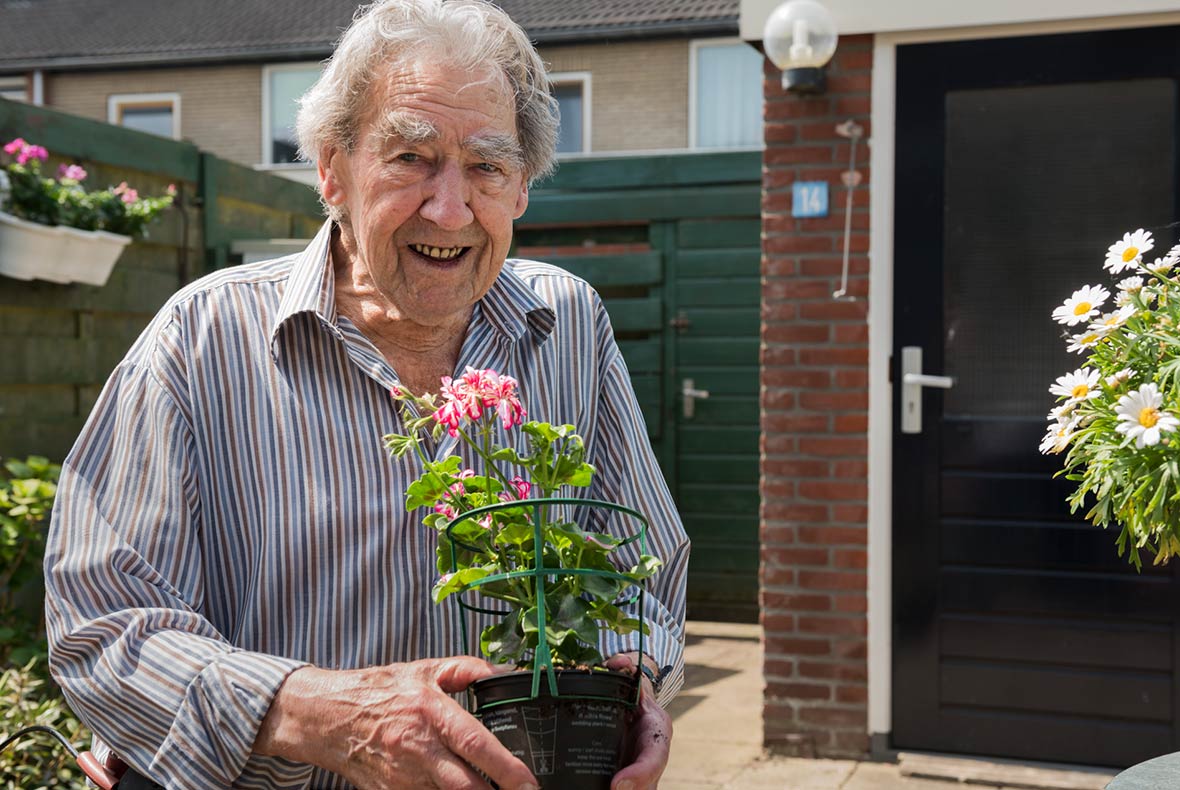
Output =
[{"x1": 0, "y1": 137, "x2": 176, "y2": 286}]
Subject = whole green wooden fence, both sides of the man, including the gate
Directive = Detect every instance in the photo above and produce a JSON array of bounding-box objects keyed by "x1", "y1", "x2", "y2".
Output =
[{"x1": 0, "y1": 99, "x2": 761, "y2": 620}]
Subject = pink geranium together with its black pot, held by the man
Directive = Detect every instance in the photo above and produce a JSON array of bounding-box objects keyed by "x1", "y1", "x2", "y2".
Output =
[{"x1": 385, "y1": 367, "x2": 661, "y2": 790}]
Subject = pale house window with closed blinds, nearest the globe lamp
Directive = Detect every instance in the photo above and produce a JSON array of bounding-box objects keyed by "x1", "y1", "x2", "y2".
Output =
[{"x1": 688, "y1": 39, "x2": 762, "y2": 148}]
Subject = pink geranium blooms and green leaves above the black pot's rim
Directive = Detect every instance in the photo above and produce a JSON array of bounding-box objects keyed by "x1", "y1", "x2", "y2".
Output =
[{"x1": 385, "y1": 367, "x2": 661, "y2": 668}]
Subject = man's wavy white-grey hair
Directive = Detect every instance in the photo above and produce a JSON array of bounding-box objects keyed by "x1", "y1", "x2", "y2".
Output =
[{"x1": 295, "y1": 0, "x2": 558, "y2": 209}]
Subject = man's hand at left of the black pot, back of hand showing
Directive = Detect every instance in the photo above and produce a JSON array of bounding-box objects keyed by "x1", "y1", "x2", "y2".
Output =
[{"x1": 254, "y1": 657, "x2": 537, "y2": 790}]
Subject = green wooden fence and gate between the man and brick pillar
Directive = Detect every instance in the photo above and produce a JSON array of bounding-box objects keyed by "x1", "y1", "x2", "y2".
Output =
[{"x1": 514, "y1": 151, "x2": 761, "y2": 621}]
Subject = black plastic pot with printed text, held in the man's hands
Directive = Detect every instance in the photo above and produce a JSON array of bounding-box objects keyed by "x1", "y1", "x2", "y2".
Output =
[{"x1": 471, "y1": 670, "x2": 637, "y2": 790}]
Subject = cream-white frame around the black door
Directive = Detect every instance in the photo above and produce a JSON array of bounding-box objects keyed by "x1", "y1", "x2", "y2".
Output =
[{"x1": 867, "y1": 12, "x2": 1180, "y2": 752}]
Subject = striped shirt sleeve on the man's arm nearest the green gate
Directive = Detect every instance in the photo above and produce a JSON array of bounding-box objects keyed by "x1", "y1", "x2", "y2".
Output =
[{"x1": 589, "y1": 307, "x2": 689, "y2": 705}]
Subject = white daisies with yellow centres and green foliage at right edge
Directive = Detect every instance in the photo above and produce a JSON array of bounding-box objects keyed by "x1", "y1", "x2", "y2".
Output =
[{"x1": 1041, "y1": 229, "x2": 1180, "y2": 567}]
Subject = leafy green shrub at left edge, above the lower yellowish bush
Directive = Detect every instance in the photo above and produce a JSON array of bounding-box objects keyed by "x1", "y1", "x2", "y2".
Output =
[{"x1": 0, "y1": 456, "x2": 61, "y2": 666}]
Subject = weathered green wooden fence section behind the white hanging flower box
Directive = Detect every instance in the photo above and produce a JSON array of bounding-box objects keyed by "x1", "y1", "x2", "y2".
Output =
[{"x1": 0, "y1": 99, "x2": 322, "y2": 461}]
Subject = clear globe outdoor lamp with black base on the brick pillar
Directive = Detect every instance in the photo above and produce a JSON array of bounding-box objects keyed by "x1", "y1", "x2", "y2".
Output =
[{"x1": 762, "y1": 0, "x2": 837, "y2": 93}]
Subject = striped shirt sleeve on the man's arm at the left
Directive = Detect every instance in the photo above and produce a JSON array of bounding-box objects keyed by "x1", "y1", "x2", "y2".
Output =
[{"x1": 45, "y1": 351, "x2": 312, "y2": 788}]
